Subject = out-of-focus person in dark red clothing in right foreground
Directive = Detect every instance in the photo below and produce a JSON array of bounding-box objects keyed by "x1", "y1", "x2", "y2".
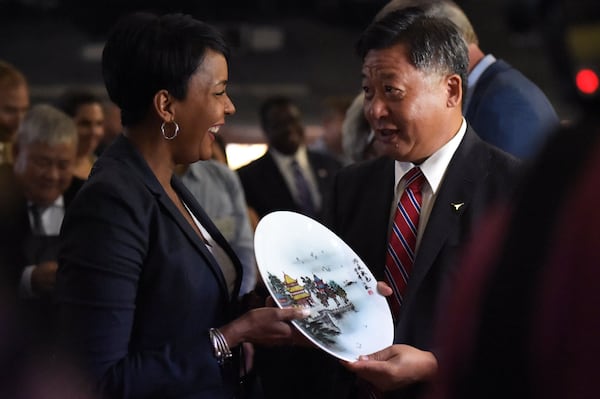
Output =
[{"x1": 430, "y1": 0, "x2": 600, "y2": 399}]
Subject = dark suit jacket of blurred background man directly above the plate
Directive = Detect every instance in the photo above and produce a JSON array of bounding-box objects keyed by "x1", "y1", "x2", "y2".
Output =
[{"x1": 238, "y1": 150, "x2": 341, "y2": 219}]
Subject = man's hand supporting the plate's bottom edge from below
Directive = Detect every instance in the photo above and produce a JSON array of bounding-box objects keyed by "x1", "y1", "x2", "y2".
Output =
[{"x1": 342, "y1": 345, "x2": 438, "y2": 392}]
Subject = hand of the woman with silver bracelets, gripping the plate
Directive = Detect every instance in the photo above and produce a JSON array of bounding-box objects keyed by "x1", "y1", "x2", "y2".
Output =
[{"x1": 219, "y1": 307, "x2": 310, "y2": 348}]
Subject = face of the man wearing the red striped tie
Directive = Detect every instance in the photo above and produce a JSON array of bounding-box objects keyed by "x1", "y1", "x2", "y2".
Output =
[{"x1": 362, "y1": 44, "x2": 462, "y2": 164}]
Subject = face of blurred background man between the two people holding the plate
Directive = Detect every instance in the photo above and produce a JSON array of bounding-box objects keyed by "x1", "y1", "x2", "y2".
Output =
[{"x1": 265, "y1": 105, "x2": 304, "y2": 155}]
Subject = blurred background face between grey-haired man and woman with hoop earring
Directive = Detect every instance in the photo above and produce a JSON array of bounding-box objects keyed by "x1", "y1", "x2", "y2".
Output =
[{"x1": 73, "y1": 103, "x2": 104, "y2": 157}]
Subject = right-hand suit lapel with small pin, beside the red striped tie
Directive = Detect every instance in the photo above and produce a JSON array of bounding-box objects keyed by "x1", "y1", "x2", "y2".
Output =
[{"x1": 407, "y1": 127, "x2": 487, "y2": 299}]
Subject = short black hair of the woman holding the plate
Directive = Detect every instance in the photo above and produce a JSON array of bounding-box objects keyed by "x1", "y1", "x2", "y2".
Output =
[{"x1": 102, "y1": 12, "x2": 229, "y2": 126}]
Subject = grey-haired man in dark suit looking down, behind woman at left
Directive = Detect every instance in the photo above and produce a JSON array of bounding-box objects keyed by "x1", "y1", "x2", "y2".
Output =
[{"x1": 0, "y1": 104, "x2": 83, "y2": 350}]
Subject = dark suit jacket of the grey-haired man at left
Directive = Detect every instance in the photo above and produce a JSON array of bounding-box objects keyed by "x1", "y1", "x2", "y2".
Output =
[{"x1": 0, "y1": 165, "x2": 84, "y2": 345}]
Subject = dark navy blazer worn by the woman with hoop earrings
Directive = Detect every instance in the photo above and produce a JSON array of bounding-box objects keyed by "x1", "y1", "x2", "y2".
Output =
[{"x1": 56, "y1": 136, "x2": 242, "y2": 399}]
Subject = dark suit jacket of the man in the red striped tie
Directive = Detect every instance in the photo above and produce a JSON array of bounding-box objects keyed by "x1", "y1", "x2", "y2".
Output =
[{"x1": 325, "y1": 127, "x2": 520, "y2": 397}]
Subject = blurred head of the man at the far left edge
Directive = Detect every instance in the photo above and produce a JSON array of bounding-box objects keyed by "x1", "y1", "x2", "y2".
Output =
[{"x1": 0, "y1": 60, "x2": 29, "y2": 163}]
